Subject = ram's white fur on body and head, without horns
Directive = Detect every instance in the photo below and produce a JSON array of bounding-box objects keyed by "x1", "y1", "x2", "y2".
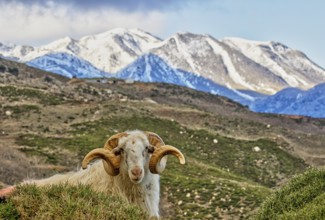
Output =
[{"x1": 25, "y1": 131, "x2": 161, "y2": 217}]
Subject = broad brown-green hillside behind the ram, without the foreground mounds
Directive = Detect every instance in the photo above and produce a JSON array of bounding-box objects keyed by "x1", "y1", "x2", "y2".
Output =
[{"x1": 0, "y1": 59, "x2": 325, "y2": 219}]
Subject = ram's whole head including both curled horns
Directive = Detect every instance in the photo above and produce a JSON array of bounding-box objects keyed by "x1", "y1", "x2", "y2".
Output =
[{"x1": 82, "y1": 131, "x2": 185, "y2": 183}]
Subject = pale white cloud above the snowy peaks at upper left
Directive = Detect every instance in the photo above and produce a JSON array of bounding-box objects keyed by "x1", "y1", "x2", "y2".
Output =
[{"x1": 0, "y1": 1, "x2": 166, "y2": 45}]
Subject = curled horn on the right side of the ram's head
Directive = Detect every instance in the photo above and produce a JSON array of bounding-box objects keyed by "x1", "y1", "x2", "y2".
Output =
[{"x1": 149, "y1": 145, "x2": 185, "y2": 173}]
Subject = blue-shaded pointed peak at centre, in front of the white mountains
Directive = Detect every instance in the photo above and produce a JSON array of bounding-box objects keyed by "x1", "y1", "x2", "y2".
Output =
[{"x1": 116, "y1": 54, "x2": 257, "y2": 105}]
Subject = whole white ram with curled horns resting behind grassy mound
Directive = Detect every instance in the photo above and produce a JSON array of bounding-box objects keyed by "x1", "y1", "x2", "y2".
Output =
[{"x1": 0, "y1": 130, "x2": 185, "y2": 217}]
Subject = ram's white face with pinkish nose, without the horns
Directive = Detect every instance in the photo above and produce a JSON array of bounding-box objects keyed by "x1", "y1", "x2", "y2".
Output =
[{"x1": 119, "y1": 135, "x2": 153, "y2": 184}]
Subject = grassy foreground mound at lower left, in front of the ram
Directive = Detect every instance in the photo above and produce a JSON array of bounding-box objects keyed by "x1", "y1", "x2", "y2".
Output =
[{"x1": 0, "y1": 185, "x2": 147, "y2": 220}]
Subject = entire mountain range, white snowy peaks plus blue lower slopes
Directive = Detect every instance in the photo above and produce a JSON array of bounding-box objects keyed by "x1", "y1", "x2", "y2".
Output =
[{"x1": 0, "y1": 28, "x2": 325, "y2": 117}]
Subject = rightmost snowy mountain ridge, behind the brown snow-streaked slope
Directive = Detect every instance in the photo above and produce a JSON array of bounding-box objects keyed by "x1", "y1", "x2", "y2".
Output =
[{"x1": 223, "y1": 38, "x2": 324, "y2": 89}]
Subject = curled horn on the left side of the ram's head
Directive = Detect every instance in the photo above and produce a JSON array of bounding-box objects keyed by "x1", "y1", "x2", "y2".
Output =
[{"x1": 82, "y1": 148, "x2": 121, "y2": 176}]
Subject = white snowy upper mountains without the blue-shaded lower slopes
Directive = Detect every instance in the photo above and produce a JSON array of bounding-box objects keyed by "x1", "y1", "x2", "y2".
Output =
[{"x1": 0, "y1": 28, "x2": 325, "y2": 94}]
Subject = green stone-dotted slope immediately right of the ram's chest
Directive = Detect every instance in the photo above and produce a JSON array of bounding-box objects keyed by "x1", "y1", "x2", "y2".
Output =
[{"x1": 161, "y1": 161, "x2": 269, "y2": 219}]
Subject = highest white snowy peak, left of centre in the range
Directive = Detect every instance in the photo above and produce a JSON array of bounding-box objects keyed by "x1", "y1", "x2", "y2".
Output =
[{"x1": 79, "y1": 28, "x2": 161, "y2": 73}]
